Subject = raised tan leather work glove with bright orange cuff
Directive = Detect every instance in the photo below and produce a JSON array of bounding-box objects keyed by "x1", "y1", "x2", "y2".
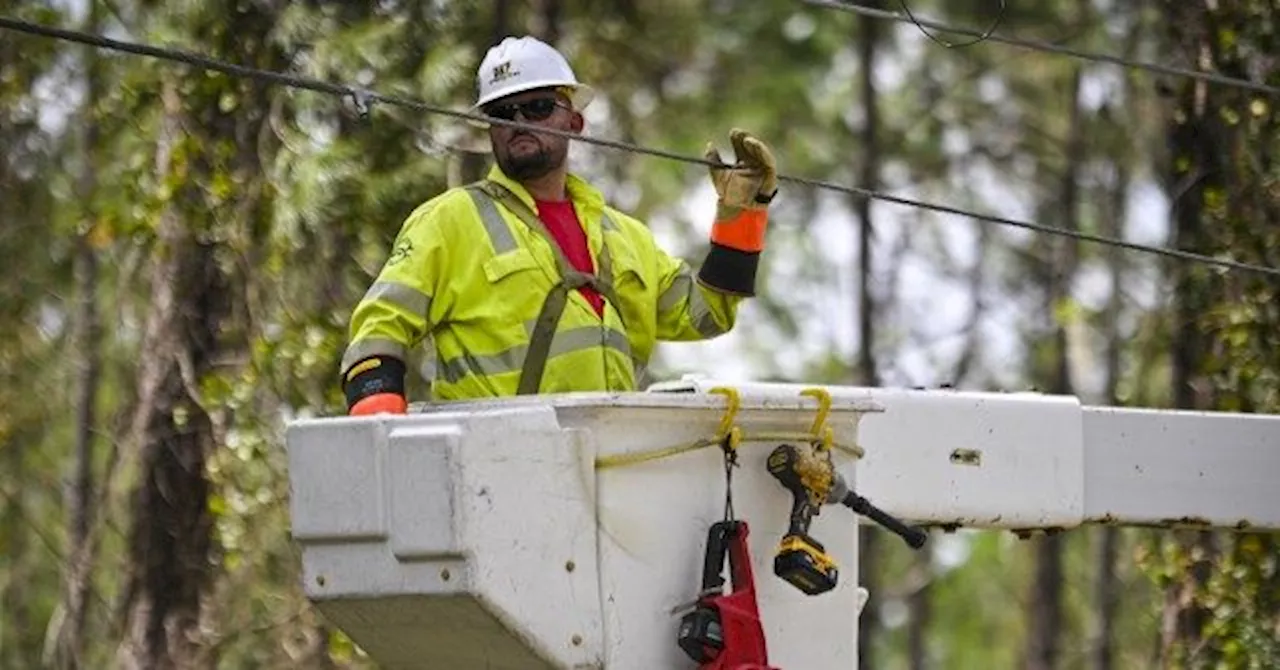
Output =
[{"x1": 704, "y1": 128, "x2": 778, "y2": 254}]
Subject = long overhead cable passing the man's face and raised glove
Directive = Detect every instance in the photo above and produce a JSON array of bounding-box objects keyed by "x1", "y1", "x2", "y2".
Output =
[{"x1": 0, "y1": 15, "x2": 1280, "y2": 277}]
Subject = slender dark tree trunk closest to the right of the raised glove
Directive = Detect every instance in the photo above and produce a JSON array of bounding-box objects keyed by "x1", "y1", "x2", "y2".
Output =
[{"x1": 854, "y1": 3, "x2": 881, "y2": 670}]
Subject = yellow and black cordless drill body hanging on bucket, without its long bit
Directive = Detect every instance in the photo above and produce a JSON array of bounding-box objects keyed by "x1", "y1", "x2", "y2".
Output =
[{"x1": 767, "y1": 445, "x2": 840, "y2": 596}]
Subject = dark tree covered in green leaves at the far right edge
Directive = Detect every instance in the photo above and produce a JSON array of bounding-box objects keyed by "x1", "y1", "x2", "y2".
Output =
[{"x1": 1155, "y1": 3, "x2": 1280, "y2": 670}]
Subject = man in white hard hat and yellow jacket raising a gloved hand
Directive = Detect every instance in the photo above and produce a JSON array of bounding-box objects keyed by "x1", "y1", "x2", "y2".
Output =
[{"x1": 342, "y1": 37, "x2": 777, "y2": 415}]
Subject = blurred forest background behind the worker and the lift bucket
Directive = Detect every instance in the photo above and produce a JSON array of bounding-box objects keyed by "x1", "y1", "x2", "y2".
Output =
[{"x1": 0, "y1": 0, "x2": 1280, "y2": 670}]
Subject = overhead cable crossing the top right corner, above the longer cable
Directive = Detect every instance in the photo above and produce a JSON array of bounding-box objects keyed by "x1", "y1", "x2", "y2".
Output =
[{"x1": 800, "y1": 0, "x2": 1280, "y2": 97}]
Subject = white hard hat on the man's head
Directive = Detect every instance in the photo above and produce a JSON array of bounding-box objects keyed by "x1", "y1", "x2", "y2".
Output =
[{"x1": 472, "y1": 37, "x2": 595, "y2": 110}]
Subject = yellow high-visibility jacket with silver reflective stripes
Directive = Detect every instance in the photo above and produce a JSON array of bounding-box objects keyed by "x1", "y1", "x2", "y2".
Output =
[{"x1": 342, "y1": 167, "x2": 744, "y2": 400}]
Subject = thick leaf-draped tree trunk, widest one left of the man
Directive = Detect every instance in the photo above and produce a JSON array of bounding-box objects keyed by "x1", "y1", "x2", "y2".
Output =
[{"x1": 118, "y1": 3, "x2": 284, "y2": 670}]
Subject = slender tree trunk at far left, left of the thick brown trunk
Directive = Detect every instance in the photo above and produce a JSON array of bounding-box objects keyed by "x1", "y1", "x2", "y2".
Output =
[{"x1": 56, "y1": 3, "x2": 102, "y2": 669}]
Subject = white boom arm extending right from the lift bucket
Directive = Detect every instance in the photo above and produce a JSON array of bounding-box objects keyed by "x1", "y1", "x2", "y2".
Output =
[{"x1": 654, "y1": 379, "x2": 1280, "y2": 529}]
